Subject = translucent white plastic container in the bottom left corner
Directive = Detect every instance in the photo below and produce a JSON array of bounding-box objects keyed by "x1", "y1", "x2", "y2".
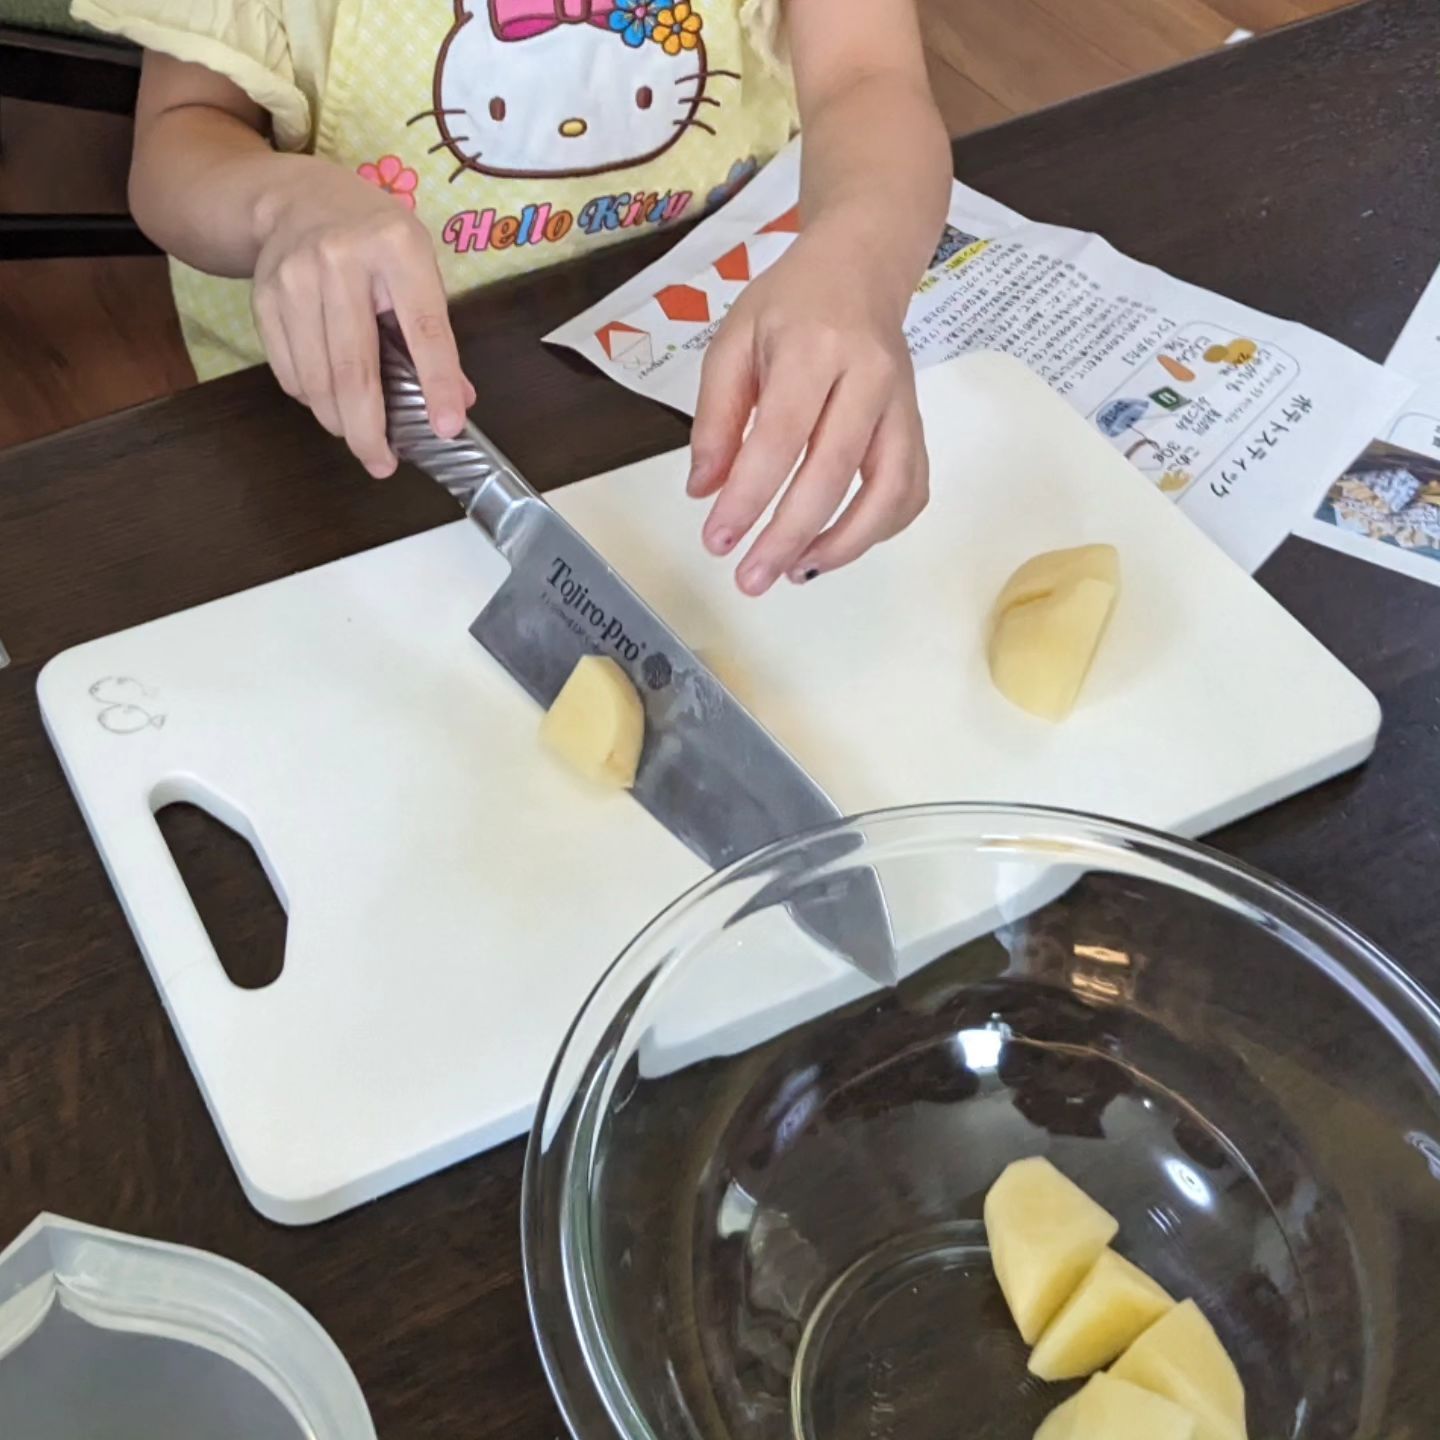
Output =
[{"x1": 0, "y1": 1215, "x2": 374, "y2": 1440}]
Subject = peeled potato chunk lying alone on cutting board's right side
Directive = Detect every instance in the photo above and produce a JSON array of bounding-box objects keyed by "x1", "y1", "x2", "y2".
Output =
[{"x1": 989, "y1": 544, "x2": 1120, "y2": 720}]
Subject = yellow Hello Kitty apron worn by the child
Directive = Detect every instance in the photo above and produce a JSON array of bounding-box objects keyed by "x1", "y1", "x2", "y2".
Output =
[{"x1": 171, "y1": 0, "x2": 795, "y2": 379}]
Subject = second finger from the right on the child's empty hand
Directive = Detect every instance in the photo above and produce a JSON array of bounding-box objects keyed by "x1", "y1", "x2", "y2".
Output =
[{"x1": 736, "y1": 370, "x2": 886, "y2": 595}]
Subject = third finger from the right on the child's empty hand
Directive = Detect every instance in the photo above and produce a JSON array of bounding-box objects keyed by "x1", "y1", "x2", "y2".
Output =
[{"x1": 704, "y1": 354, "x2": 834, "y2": 554}]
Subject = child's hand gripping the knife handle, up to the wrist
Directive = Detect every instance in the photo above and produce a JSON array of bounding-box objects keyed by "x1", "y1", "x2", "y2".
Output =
[{"x1": 253, "y1": 157, "x2": 475, "y2": 477}]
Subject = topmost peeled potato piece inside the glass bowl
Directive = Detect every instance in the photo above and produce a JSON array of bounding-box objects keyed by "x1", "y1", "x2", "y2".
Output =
[{"x1": 985, "y1": 1155, "x2": 1120, "y2": 1345}]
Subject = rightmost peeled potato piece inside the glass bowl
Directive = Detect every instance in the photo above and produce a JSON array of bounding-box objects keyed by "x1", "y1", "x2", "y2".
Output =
[{"x1": 1110, "y1": 1300, "x2": 1246, "y2": 1440}]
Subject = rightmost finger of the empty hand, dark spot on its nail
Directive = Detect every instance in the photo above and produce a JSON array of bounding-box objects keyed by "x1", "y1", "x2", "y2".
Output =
[{"x1": 791, "y1": 400, "x2": 930, "y2": 580}]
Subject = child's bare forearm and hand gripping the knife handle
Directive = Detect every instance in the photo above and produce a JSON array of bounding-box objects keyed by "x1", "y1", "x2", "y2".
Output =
[{"x1": 130, "y1": 53, "x2": 475, "y2": 475}]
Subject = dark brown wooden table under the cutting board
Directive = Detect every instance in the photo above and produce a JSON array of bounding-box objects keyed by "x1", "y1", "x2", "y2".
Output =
[{"x1": 0, "y1": 0, "x2": 1440, "y2": 1440}]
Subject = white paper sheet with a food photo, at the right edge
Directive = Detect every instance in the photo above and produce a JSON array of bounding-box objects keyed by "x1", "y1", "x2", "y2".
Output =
[{"x1": 1296, "y1": 262, "x2": 1440, "y2": 585}]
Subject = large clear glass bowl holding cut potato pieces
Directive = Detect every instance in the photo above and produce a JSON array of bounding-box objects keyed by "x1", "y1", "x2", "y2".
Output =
[{"x1": 524, "y1": 805, "x2": 1440, "y2": 1440}]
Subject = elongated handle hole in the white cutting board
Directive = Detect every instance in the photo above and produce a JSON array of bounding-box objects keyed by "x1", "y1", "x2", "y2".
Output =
[{"x1": 151, "y1": 782, "x2": 287, "y2": 991}]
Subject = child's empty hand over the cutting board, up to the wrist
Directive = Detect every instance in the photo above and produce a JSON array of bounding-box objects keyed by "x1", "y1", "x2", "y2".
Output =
[{"x1": 688, "y1": 232, "x2": 929, "y2": 595}]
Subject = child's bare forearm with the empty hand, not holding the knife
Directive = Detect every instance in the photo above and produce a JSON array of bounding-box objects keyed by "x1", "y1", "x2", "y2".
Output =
[{"x1": 690, "y1": 0, "x2": 950, "y2": 595}]
